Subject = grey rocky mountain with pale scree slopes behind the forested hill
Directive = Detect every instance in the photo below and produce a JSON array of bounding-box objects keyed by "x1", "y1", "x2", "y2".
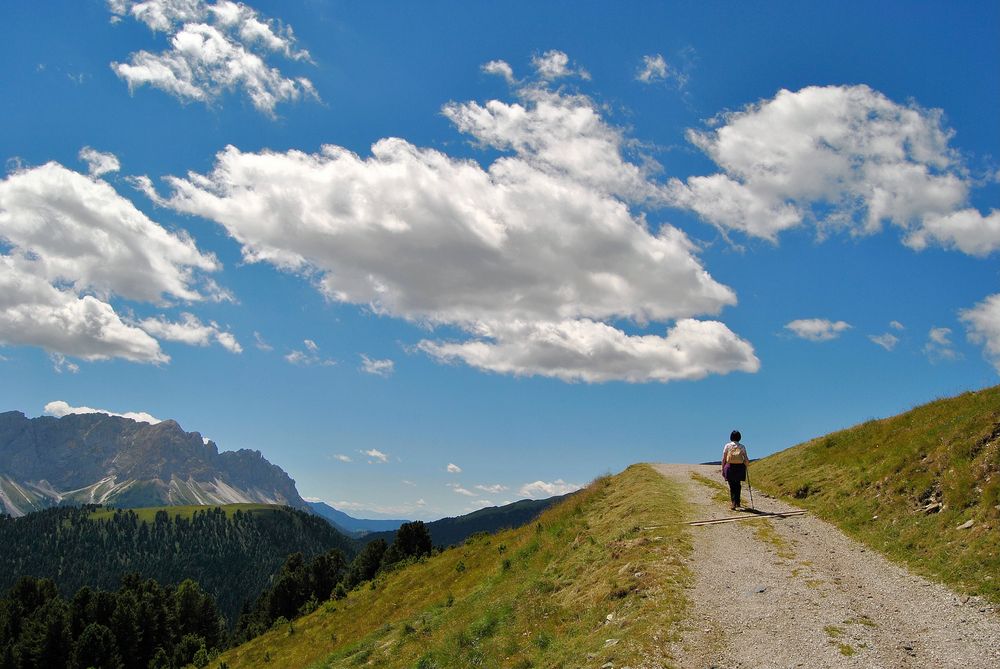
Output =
[{"x1": 0, "y1": 411, "x2": 309, "y2": 516}]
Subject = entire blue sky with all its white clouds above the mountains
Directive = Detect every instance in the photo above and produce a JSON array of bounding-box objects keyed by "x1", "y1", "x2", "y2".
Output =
[{"x1": 0, "y1": 0, "x2": 1000, "y2": 519}]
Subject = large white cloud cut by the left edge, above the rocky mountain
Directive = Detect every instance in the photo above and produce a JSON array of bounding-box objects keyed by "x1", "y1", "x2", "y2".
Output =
[{"x1": 0, "y1": 162, "x2": 227, "y2": 363}]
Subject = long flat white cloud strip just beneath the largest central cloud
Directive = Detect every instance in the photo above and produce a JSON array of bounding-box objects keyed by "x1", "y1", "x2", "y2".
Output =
[{"x1": 418, "y1": 318, "x2": 760, "y2": 383}]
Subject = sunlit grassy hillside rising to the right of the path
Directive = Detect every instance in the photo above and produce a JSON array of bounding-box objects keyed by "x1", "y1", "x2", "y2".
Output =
[{"x1": 751, "y1": 386, "x2": 1000, "y2": 602}]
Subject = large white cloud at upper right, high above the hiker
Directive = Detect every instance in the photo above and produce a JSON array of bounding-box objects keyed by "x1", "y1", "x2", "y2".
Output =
[{"x1": 668, "y1": 86, "x2": 1000, "y2": 255}]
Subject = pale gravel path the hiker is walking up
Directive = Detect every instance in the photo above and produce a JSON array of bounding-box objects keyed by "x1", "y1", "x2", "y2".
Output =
[{"x1": 655, "y1": 465, "x2": 1000, "y2": 669}]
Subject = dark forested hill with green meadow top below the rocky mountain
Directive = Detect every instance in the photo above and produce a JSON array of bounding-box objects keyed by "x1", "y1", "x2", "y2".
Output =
[{"x1": 0, "y1": 504, "x2": 357, "y2": 624}]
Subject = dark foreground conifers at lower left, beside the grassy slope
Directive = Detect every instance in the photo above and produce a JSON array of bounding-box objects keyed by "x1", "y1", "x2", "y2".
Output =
[{"x1": 0, "y1": 514, "x2": 432, "y2": 669}]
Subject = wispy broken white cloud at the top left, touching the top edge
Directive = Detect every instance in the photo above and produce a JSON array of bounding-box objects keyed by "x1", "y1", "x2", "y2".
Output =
[{"x1": 109, "y1": 0, "x2": 317, "y2": 116}]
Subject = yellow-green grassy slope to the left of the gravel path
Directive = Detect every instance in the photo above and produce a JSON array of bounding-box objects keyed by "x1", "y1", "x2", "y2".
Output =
[{"x1": 220, "y1": 465, "x2": 690, "y2": 669}]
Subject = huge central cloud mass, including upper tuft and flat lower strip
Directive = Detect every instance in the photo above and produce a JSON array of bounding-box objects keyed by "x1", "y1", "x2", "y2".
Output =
[{"x1": 157, "y1": 70, "x2": 759, "y2": 381}]
